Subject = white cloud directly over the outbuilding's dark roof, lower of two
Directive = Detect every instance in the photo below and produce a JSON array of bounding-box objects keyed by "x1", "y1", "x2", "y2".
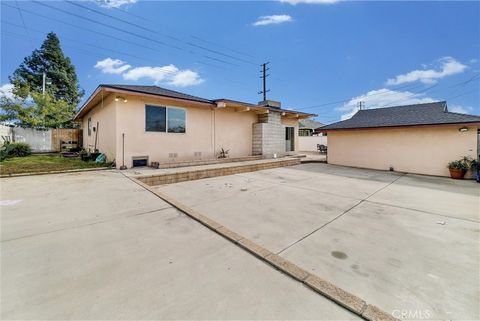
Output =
[{"x1": 337, "y1": 88, "x2": 435, "y2": 120}]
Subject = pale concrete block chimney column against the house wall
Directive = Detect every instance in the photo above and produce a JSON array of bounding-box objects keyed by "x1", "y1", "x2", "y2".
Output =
[{"x1": 252, "y1": 111, "x2": 285, "y2": 156}]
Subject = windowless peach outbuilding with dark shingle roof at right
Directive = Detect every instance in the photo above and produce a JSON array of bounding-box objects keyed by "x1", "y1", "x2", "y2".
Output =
[{"x1": 321, "y1": 101, "x2": 480, "y2": 176}]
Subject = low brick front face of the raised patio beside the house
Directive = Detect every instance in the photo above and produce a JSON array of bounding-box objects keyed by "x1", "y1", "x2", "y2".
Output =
[{"x1": 135, "y1": 158, "x2": 300, "y2": 186}]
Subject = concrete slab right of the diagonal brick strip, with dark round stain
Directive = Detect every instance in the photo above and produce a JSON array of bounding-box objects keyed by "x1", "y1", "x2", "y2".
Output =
[{"x1": 157, "y1": 164, "x2": 480, "y2": 320}]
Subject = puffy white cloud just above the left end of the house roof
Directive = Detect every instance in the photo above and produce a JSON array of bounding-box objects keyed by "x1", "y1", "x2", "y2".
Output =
[{"x1": 95, "y1": 58, "x2": 204, "y2": 87}]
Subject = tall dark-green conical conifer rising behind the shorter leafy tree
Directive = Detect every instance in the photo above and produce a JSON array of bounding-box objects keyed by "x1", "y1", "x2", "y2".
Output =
[{"x1": 9, "y1": 32, "x2": 84, "y2": 106}]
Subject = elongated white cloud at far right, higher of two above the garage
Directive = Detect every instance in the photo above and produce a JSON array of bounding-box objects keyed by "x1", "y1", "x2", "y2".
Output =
[{"x1": 387, "y1": 57, "x2": 467, "y2": 85}]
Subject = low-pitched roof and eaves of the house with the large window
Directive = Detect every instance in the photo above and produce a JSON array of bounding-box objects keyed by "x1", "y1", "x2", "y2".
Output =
[{"x1": 75, "y1": 84, "x2": 314, "y2": 120}]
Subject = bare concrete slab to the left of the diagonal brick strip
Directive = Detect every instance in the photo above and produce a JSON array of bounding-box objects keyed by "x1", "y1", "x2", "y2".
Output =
[{"x1": 1, "y1": 171, "x2": 357, "y2": 320}]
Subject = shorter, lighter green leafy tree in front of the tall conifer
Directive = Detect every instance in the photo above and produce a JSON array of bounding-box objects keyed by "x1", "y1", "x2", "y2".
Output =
[{"x1": 0, "y1": 92, "x2": 75, "y2": 128}]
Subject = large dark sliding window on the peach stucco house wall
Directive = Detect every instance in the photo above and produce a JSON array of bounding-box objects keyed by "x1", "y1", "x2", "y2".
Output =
[{"x1": 145, "y1": 105, "x2": 186, "y2": 133}]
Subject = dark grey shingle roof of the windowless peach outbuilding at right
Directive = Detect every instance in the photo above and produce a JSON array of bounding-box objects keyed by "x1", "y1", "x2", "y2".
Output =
[{"x1": 321, "y1": 101, "x2": 480, "y2": 130}]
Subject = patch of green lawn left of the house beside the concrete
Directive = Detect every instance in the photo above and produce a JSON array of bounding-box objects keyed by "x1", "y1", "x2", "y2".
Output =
[{"x1": 0, "y1": 154, "x2": 110, "y2": 175}]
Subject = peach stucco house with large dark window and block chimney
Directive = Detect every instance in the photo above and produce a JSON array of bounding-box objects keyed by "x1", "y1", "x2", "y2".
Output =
[{"x1": 75, "y1": 85, "x2": 312, "y2": 167}]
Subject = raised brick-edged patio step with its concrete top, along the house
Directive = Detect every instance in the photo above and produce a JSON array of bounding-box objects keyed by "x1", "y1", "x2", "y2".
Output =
[{"x1": 134, "y1": 158, "x2": 300, "y2": 186}]
